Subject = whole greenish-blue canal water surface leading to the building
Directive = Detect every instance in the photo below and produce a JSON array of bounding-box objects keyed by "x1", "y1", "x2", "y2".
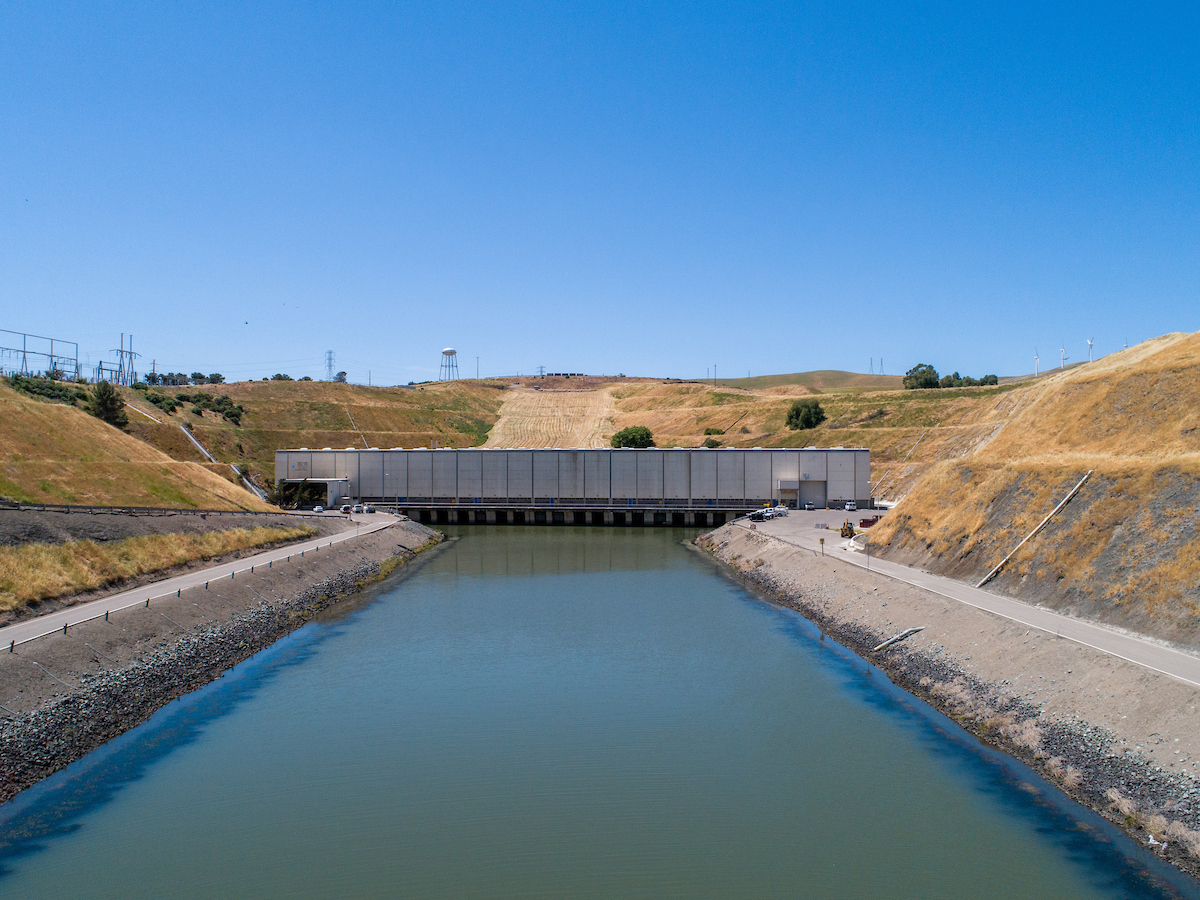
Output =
[{"x1": 0, "y1": 527, "x2": 1196, "y2": 900}]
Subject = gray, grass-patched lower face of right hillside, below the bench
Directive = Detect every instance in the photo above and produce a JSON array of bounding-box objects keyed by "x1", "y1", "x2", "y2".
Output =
[{"x1": 872, "y1": 468, "x2": 1200, "y2": 649}]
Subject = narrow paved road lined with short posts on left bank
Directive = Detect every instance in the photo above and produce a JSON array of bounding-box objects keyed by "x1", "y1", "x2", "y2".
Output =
[{"x1": 0, "y1": 514, "x2": 398, "y2": 649}]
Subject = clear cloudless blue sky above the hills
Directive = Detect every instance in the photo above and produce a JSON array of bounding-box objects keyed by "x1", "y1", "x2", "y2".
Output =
[{"x1": 0, "y1": 2, "x2": 1200, "y2": 384}]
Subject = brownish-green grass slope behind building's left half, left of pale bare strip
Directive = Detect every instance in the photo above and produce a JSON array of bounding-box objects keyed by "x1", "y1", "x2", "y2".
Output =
[{"x1": 122, "y1": 380, "x2": 503, "y2": 485}]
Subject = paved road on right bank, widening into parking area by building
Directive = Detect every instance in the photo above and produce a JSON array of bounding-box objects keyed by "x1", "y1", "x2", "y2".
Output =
[{"x1": 737, "y1": 510, "x2": 1200, "y2": 686}]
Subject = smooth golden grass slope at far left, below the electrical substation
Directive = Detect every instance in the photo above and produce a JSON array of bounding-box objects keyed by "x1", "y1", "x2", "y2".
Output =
[{"x1": 0, "y1": 382, "x2": 269, "y2": 510}]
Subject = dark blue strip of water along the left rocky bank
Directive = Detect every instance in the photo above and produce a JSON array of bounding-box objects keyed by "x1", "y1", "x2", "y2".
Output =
[{"x1": 0, "y1": 625, "x2": 334, "y2": 878}]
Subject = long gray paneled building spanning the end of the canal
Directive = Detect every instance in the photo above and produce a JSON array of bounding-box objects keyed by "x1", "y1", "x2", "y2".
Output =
[{"x1": 275, "y1": 448, "x2": 871, "y2": 524}]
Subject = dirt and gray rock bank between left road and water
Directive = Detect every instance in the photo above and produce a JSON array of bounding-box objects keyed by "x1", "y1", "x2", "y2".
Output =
[{"x1": 0, "y1": 522, "x2": 442, "y2": 802}]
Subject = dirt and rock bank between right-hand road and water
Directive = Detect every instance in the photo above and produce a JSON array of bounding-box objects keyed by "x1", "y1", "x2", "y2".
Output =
[{"x1": 697, "y1": 524, "x2": 1200, "y2": 876}]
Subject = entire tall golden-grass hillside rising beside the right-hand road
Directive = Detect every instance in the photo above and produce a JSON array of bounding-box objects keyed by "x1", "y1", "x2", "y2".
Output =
[{"x1": 872, "y1": 335, "x2": 1200, "y2": 646}]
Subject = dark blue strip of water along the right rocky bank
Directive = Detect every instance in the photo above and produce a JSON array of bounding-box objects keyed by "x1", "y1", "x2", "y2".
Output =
[{"x1": 715, "y1": 566, "x2": 1200, "y2": 900}]
